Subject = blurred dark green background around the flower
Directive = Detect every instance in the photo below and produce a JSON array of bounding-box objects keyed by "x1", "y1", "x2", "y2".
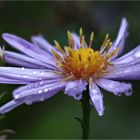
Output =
[{"x1": 0, "y1": 1, "x2": 140, "y2": 139}]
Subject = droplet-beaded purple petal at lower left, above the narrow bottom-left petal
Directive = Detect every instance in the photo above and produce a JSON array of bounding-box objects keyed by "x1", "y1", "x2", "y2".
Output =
[{"x1": 13, "y1": 81, "x2": 65, "y2": 102}]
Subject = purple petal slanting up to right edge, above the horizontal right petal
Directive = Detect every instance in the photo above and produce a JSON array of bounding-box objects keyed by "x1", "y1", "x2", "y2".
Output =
[{"x1": 113, "y1": 45, "x2": 140, "y2": 65}]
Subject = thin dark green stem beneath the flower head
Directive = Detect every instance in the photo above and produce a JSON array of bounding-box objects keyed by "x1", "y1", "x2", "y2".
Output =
[{"x1": 81, "y1": 91, "x2": 91, "y2": 139}]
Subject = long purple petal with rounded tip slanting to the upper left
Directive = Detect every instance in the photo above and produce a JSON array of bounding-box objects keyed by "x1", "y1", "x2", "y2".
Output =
[{"x1": 2, "y1": 33, "x2": 57, "y2": 67}]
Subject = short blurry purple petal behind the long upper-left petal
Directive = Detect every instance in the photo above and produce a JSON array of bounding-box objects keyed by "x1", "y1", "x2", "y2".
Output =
[{"x1": 31, "y1": 35, "x2": 63, "y2": 57}]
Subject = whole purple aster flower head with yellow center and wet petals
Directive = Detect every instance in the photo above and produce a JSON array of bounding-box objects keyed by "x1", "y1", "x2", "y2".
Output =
[{"x1": 0, "y1": 18, "x2": 140, "y2": 116}]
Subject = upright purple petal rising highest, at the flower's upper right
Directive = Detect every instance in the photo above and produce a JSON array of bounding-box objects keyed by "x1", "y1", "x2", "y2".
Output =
[{"x1": 109, "y1": 18, "x2": 128, "y2": 58}]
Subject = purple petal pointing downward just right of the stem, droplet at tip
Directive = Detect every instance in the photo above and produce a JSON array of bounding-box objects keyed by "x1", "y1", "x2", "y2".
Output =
[{"x1": 89, "y1": 83, "x2": 104, "y2": 116}]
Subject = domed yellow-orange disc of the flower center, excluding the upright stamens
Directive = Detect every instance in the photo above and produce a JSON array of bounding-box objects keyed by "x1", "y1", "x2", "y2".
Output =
[{"x1": 61, "y1": 48, "x2": 109, "y2": 79}]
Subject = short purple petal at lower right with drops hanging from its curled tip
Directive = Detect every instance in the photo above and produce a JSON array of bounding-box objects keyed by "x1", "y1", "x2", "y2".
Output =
[{"x1": 96, "y1": 79, "x2": 132, "y2": 96}]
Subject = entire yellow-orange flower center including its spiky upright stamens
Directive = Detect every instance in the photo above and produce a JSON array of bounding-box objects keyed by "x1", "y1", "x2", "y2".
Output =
[{"x1": 52, "y1": 30, "x2": 117, "y2": 80}]
